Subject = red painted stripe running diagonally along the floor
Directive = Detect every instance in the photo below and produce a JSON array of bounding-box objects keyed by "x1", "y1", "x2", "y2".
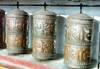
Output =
[{"x1": 0, "y1": 55, "x2": 56, "y2": 69}]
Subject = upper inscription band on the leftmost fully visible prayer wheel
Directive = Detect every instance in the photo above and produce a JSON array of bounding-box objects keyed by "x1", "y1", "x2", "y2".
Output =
[{"x1": 7, "y1": 17, "x2": 27, "y2": 32}]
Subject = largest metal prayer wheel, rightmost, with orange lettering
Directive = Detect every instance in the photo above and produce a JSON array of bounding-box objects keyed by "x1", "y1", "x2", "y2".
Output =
[{"x1": 64, "y1": 13, "x2": 95, "y2": 69}]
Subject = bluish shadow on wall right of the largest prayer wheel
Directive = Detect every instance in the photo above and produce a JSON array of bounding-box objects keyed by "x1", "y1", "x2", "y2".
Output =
[{"x1": 92, "y1": 20, "x2": 100, "y2": 59}]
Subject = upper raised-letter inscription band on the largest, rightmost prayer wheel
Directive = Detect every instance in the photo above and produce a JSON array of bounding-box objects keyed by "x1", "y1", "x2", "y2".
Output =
[{"x1": 65, "y1": 25, "x2": 92, "y2": 44}]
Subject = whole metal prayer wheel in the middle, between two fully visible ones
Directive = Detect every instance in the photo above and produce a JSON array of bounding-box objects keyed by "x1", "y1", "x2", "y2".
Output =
[{"x1": 32, "y1": 10, "x2": 56, "y2": 60}]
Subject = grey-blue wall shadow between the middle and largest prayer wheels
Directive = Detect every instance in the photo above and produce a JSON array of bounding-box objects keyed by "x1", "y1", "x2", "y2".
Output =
[{"x1": 56, "y1": 15, "x2": 66, "y2": 54}]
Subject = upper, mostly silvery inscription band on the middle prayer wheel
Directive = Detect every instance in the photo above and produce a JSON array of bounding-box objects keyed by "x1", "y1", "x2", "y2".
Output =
[{"x1": 33, "y1": 22, "x2": 54, "y2": 36}]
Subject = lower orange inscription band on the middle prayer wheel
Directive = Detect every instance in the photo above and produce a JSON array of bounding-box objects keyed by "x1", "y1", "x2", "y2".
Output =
[{"x1": 33, "y1": 39, "x2": 53, "y2": 53}]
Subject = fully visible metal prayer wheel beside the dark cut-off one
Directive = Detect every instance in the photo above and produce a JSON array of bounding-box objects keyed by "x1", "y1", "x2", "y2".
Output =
[{"x1": 6, "y1": 9, "x2": 29, "y2": 54}]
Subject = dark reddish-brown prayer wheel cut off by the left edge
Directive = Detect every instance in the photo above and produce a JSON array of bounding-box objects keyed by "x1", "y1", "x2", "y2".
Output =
[{"x1": 0, "y1": 9, "x2": 6, "y2": 49}]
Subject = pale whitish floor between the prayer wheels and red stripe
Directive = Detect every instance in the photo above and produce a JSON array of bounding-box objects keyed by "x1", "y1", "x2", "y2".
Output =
[{"x1": 0, "y1": 49, "x2": 97, "y2": 69}]
